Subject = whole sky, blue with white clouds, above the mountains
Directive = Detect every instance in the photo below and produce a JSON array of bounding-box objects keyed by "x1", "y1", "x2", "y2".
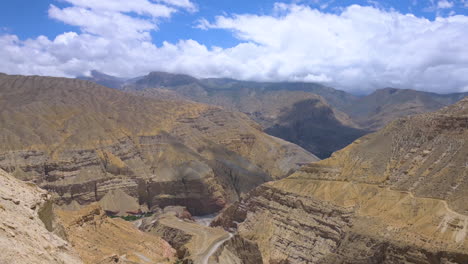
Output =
[{"x1": 0, "y1": 0, "x2": 468, "y2": 93}]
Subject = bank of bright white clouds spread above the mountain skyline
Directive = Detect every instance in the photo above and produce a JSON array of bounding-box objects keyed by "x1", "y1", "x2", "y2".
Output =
[{"x1": 0, "y1": 0, "x2": 468, "y2": 92}]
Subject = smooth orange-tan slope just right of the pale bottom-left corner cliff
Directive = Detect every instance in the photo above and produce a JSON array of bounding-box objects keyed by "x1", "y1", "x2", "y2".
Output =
[{"x1": 57, "y1": 204, "x2": 176, "y2": 264}]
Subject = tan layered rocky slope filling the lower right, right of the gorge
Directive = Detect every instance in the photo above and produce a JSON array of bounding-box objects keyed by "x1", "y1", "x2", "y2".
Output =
[{"x1": 213, "y1": 98, "x2": 468, "y2": 264}]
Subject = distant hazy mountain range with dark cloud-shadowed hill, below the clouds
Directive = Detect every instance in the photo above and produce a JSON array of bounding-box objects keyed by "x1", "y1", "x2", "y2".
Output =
[{"x1": 83, "y1": 71, "x2": 468, "y2": 158}]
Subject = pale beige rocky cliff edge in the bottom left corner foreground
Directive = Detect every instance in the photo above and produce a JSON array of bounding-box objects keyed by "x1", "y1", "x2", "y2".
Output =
[{"x1": 0, "y1": 170, "x2": 82, "y2": 264}]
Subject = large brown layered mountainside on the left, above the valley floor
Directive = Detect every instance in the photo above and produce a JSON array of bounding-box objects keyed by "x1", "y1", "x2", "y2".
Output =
[{"x1": 0, "y1": 75, "x2": 317, "y2": 215}]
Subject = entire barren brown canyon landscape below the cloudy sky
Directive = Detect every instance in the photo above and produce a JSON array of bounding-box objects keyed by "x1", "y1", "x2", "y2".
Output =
[{"x1": 0, "y1": 73, "x2": 468, "y2": 264}]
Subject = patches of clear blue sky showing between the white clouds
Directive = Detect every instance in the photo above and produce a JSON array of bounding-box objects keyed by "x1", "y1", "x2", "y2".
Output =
[{"x1": 0, "y1": 0, "x2": 468, "y2": 48}]
